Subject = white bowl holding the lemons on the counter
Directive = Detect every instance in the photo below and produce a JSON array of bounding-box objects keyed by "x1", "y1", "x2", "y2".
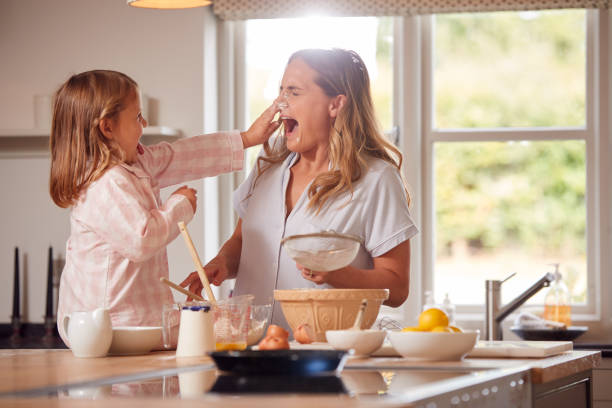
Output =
[{"x1": 387, "y1": 330, "x2": 479, "y2": 361}]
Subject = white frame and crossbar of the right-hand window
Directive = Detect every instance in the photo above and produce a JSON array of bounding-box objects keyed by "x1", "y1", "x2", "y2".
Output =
[{"x1": 412, "y1": 10, "x2": 610, "y2": 325}]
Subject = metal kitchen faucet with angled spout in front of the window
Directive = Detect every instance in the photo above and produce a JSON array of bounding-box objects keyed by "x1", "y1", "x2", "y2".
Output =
[{"x1": 485, "y1": 272, "x2": 555, "y2": 340}]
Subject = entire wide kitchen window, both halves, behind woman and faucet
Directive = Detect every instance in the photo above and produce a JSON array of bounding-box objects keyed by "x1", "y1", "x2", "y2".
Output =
[{"x1": 233, "y1": 9, "x2": 612, "y2": 324}]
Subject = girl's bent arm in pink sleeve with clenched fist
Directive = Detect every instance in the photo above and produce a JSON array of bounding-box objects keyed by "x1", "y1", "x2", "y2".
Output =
[{"x1": 76, "y1": 173, "x2": 194, "y2": 262}]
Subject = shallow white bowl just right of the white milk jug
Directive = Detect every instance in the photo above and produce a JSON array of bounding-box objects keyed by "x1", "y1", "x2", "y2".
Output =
[{"x1": 108, "y1": 326, "x2": 162, "y2": 355}]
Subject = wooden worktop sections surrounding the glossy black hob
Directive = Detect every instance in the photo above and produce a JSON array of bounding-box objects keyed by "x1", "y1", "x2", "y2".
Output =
[{"x1": 0, "y1": 350, "x2": 601, "y2": 408}]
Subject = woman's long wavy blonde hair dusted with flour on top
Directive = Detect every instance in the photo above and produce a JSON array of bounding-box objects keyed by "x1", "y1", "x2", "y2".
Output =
[{"x1": 255, "y1": 48, "x2": 410, "y2": 213}]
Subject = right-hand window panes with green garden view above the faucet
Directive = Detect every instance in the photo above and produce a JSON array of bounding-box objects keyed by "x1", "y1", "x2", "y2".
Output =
[{"x1": 424, "y1": 10, "x2": 593, "y2": 310}]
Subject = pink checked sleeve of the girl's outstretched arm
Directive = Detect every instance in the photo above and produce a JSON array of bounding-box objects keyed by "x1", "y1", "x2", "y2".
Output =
[{"x1": 139, "y1": 131, "x2": 244, "y2": 188}]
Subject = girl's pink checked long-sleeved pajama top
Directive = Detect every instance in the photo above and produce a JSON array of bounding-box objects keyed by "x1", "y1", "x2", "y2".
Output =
[{"x1": 57, "y1": 131, "x2": 244, "y2": 345}]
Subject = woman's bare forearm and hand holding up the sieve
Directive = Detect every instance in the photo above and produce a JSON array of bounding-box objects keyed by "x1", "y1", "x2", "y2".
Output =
[{"x1": 298, "y1": 240, "x2": 410, "y2": 307}]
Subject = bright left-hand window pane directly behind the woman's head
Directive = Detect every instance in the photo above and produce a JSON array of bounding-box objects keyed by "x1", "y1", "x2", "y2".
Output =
[{"x1": 246, "y1": 17, "x2": 393, "y2": 169}]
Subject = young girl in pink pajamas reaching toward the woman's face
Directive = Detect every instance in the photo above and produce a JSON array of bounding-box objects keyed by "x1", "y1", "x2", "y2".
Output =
[{"x1": 49, "y1": 70, "x2": 278, "y2": 345}]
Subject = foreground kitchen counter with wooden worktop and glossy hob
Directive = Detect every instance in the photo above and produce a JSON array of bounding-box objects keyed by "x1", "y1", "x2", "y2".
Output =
[{"x1": 0, "y1": 350, "x2": 601, "y2": 408}]
